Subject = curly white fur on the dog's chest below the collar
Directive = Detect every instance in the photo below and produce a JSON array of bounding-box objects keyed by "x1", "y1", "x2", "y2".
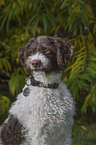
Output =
[{"x1": 9, "y1": 72, "x2": 74, "y2": 145}]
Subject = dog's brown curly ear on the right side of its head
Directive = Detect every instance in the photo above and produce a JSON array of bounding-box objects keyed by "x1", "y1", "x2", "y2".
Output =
[{"x1": 55, "y1": 38, "x2": 74, "y2": 70}]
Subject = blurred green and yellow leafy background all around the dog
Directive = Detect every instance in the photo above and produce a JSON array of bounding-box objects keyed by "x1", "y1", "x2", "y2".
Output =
[{"x1": 0, "y1": 0, "x2": 96, "y2": 145}]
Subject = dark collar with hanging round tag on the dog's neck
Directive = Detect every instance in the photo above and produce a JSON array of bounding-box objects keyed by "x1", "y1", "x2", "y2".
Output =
[{"x1": 23, "y1": 76, "x2": 59, "y2": 96}]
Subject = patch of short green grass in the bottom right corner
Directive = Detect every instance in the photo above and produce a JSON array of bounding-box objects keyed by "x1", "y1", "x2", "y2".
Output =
[{"x1": 72, "y1": 121, "x2": 96, "y2": 145}]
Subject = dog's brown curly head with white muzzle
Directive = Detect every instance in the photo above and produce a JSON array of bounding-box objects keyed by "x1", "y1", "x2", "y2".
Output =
[{"x1": 19, "y1": 36, "x2": 73, "y2": 73}]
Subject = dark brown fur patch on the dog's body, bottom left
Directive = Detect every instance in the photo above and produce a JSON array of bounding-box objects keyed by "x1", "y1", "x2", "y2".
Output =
[{"x1": 1, "y1": 115, "x2": 24, "y2": 145}]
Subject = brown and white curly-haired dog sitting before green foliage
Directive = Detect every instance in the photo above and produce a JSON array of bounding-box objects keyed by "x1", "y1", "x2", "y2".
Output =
[{"x1": 0, "y1": 36, "x2": 75, "y2": 145}]
